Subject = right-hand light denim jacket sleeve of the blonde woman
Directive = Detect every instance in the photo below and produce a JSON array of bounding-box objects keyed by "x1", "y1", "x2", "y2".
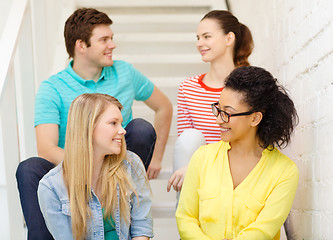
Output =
[{"x1": 128, "y1": 152, "x2": 154, "y2": 238}]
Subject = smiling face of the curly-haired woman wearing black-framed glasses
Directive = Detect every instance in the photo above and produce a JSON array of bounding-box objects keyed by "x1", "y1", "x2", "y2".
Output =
[{"x1": 216, "y1": 88, "x2": 261, "y2": 142}]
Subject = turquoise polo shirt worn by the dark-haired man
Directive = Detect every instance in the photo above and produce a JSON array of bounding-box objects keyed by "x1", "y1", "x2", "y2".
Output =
[{"x1": 35, "y1": 61, "x2": 154, "y2": 148}]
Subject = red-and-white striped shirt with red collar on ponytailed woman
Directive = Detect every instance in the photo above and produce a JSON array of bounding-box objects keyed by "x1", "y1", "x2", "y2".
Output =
[{"x1": 177, "y1": 74, "x2": 223, "y2": 144}]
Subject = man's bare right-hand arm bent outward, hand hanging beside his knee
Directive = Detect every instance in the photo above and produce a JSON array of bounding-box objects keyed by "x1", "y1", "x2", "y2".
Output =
[{"x1": 145, "y1": 86, "x2": 172, "y2": 179}]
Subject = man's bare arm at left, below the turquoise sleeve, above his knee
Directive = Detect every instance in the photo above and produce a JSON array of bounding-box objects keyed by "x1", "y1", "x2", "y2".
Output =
[{"x1": 36, "y1": 124, "x2": 65, "y2": 165}]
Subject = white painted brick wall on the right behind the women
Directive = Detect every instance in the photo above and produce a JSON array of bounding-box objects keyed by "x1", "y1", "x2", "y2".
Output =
[{"x1": 230, "y1": 0, "x2": 333, "y2": 240}]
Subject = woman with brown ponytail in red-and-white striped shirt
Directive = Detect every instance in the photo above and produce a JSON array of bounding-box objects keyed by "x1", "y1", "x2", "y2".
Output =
[{"x1": 167, "y1": 10, "x2": 253, "y2": 191}]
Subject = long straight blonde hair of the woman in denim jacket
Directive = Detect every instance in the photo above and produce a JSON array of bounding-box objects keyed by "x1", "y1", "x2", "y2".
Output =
[{"x1": 63, "y1": 93, "x2": 135, "y2": 239}]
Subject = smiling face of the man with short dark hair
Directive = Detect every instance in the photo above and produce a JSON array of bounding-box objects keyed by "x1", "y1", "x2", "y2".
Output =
[{"x1": 85, "y1": 24, "x2": 116, "y2": 68}]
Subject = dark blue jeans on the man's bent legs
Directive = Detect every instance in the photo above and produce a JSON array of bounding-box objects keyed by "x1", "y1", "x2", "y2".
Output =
[{"x1": 16, "y1": 118, "x2": 156, "y2": 240}]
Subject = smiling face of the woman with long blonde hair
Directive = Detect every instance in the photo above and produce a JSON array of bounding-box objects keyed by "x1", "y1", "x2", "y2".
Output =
[{"x1": 93, "y1": 103, "x2": 126, "y2": 157}]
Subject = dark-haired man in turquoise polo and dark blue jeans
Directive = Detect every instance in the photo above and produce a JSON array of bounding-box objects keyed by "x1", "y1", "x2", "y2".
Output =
[{"x1": 16, "y1": 8, "x2": 172, "y2": 240}]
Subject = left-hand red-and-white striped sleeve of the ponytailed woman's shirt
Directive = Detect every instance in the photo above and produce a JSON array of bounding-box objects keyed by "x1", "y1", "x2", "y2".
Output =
[{"x1": 177, "y1": 82, "x2": 193, "y2": 136}]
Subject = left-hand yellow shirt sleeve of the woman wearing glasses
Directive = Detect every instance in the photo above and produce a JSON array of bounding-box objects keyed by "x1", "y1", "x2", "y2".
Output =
[{"x1": 176, "y1": 148, "x2": 210, "y2": 240}]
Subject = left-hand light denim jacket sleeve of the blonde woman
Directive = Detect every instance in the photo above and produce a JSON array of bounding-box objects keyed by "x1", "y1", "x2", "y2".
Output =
[{"x1": 37, "y1": 180, "x2": 73, "y2": 240}]
